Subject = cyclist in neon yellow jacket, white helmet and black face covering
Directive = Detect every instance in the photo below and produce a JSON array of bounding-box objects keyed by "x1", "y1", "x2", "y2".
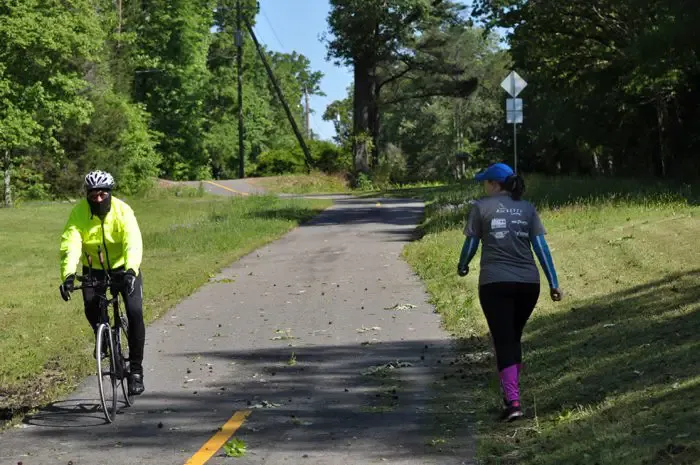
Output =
[{"x1": 60, "y1": 170, "x2": 146, "y2": 395}]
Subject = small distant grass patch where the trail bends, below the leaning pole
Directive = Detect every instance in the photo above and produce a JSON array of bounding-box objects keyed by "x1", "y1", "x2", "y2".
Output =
[{"x1": 248, "y1": 173, "x2": 352, "y2": 194}]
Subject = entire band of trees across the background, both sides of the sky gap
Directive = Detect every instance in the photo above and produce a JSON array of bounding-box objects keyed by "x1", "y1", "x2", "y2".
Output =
[{"x1": 0, "y1": 0, "x2": 700, "y2": 204}]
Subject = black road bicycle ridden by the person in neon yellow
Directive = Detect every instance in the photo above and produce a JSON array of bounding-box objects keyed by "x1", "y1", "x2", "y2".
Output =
[{"x1": 59, "y1": 246, "x2": 134, "y2": 423}]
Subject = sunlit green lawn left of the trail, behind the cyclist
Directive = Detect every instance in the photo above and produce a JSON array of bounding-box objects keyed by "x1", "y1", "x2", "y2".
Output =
[{"x1": 0, "y1": 189, "x2": 331, "y2": 421}]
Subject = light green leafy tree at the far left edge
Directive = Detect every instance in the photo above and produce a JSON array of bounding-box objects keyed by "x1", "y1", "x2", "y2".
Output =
[{"x1": 0, "y1": 0, "x2": 102, "y2": 206}]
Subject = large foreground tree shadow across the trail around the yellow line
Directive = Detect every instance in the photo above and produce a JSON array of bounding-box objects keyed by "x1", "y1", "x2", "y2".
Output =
[{"x1": 17, "y1": 336, "x2": 471, "y2": 463}]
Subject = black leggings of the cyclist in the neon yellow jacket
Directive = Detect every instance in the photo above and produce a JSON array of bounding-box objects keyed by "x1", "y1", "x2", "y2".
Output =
[{"x1": 83, "y1": 269, "x2": 146, "y2": 374}]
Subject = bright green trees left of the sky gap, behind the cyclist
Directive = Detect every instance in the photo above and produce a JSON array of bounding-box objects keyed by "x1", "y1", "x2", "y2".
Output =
[{"x1": 0, "y1": 0, "x2": 342, "y2": 204}]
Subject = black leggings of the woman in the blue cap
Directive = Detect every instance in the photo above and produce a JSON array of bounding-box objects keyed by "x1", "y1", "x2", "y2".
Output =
[{"x1": 479, "y1": 282, "x2": 540, "y2": 371}]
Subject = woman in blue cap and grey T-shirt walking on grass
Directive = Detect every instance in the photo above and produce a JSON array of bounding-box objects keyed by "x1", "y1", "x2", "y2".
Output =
[{"x1": 457, "y1": 163, "x2": 562, "y2": 421}]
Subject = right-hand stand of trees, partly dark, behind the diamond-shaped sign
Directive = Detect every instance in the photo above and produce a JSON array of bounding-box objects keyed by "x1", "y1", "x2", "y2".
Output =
[{"x1": 326, "y1": 0, "x2": 700, "y2": 179}]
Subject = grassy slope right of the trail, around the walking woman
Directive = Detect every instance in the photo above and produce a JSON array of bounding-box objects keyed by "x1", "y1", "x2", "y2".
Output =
[{"x1": 394, "y1": 177, "x2": 700, "y2": 465}]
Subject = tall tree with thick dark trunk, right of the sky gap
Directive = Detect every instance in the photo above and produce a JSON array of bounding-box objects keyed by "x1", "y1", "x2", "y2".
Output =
[{"x1": 328, "y1": 0, "x2": 476, "y2": 172}]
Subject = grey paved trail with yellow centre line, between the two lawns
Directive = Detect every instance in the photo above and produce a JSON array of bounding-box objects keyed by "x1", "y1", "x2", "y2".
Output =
[{"x1": 0, "y1": 194, "x2": 473, "y2": 465}]
